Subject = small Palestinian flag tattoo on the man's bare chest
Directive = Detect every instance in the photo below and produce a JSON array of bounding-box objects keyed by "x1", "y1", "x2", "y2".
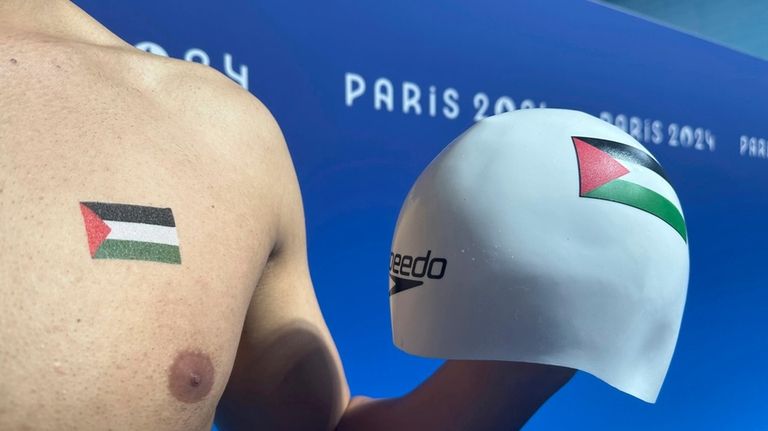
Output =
[{"x1": 80, "y1": 202, "x2": 181, "y2": 264}]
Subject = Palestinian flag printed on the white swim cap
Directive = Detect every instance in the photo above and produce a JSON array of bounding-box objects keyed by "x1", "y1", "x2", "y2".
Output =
[{"x1": 573, "y1": 136, "x2": 688, "y2": 242}]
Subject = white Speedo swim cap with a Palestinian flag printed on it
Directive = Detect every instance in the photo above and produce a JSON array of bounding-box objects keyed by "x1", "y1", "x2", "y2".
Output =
[{"x1": 390, "y1": 109, "x2": 689, "y2": 402}]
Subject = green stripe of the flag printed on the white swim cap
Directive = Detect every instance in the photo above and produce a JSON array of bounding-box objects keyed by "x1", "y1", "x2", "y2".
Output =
[{"x1": 585, "y1": 180, "x2": 688, "y2": 242}]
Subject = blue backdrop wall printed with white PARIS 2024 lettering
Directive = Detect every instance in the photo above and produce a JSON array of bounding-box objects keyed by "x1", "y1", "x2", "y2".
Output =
[{"x1": 77, "y1": 0, "x2": 768, "y2": 430}]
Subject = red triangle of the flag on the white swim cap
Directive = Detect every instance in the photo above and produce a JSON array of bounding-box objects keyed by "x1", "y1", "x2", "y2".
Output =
[{"x1": 573, "y1": 138, "x2": 629, "y2": 196}]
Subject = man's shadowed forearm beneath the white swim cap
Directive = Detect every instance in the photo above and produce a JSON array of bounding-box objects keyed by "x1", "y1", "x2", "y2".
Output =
[{"x1": 337, "y1": 361, "x2": 575, "y2": 431}]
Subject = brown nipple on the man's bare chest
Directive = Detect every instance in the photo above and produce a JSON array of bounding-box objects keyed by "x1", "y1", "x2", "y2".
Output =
[{"x1": 168, "y1": 351, "x2": 214, "y2": 403}]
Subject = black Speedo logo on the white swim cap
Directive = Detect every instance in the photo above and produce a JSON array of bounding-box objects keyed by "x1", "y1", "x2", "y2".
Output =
[{"x1": 389, "y1": 250, "x2": 448, "y2": 296}]
